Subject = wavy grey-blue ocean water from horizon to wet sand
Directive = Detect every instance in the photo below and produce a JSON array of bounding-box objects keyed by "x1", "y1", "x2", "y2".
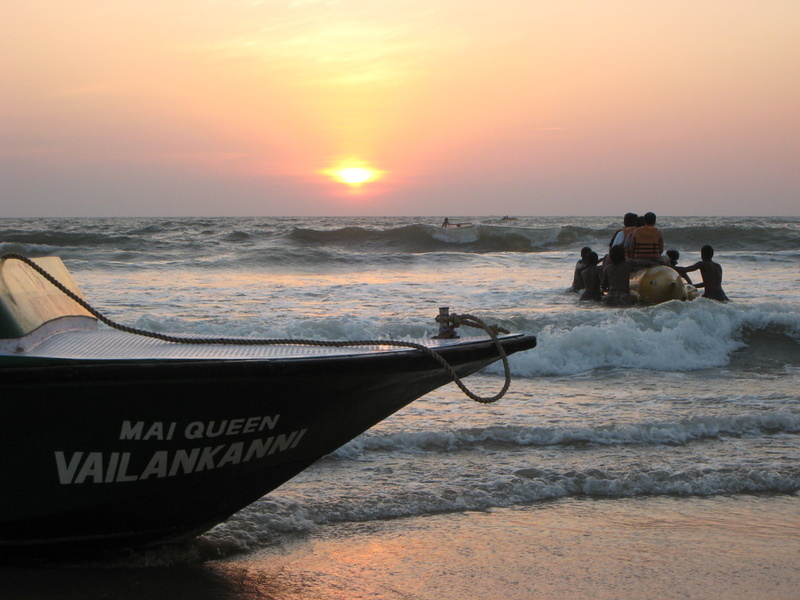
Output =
[{"x1": 0, "y1": 217, "x2": 800, "y2": 580}]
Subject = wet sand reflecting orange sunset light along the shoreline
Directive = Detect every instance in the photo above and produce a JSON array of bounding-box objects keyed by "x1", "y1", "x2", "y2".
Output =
[{"x1": 0, "y1": 495, "x2": 800, "y2": 600}]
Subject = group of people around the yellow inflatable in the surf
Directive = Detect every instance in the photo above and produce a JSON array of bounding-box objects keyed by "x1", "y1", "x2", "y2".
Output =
[{"x1": 571, "y1": 212, "x2": 728, "y2": 306}]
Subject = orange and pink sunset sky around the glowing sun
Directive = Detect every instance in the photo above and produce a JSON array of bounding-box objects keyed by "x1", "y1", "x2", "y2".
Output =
[{"x1": 0, "y1": 0, "x2": 800, "y2": 216}]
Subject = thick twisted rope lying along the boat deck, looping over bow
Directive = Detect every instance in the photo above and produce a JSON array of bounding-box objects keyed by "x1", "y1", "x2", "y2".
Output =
[{"x1": 0, "y1": 253, "x2": 511, "y2": 404}]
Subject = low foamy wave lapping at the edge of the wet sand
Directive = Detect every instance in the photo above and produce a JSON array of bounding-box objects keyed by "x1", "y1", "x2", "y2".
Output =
[{"x1": 203, "y1": 465, "x2": 800, "y2": 551}]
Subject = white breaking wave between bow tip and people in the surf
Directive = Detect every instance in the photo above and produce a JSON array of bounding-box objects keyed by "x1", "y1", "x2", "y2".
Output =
[{"x1": 500, "y1": 299, "x2": 800, "y2": 377}]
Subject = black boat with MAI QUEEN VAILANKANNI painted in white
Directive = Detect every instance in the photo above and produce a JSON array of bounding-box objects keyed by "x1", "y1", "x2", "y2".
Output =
[{"x1": 0, "y1": 256, "x2": 536, "y2": 554}]
